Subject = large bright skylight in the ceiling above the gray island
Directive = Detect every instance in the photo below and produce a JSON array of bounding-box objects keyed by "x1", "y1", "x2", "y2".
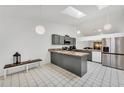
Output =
[{"x1": 62, "y1": 6, "x2": 86, "y2": 19}]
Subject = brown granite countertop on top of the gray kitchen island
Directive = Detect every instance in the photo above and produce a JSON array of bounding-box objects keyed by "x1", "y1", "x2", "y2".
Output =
[{"x1": 48, "y1": 49, "x2": 89, "y2": 57}]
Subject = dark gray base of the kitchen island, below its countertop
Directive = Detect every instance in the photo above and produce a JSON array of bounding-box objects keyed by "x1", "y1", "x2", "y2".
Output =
[{"x1": 51, "y1": 52, "x2": 87, "y2": 77}]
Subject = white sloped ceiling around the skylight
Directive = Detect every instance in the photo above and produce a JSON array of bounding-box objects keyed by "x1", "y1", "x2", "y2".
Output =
[{"x1": 0, "y1": 5, "x2": 124, "y2": 35}]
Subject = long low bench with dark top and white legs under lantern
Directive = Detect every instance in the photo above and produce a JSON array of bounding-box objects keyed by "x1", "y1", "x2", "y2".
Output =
[{"x1": 4, "y1": 59, "x2": 42, "y2": 79}]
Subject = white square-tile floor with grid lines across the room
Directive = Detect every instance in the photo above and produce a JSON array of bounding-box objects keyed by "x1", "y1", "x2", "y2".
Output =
[{"x1": 0, "y1": 62, "x2": 124, "y2": 87}]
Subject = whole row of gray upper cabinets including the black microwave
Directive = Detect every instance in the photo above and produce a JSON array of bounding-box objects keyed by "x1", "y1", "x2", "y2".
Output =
[{"x1": 52, "y1": 34, "x2": 76, "y2": 45}]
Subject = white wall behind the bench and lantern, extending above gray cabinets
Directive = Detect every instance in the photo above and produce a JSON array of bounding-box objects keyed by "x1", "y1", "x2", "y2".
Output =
[{"x1": 0, "y1": 18, "x2": 75, "y2": 74}]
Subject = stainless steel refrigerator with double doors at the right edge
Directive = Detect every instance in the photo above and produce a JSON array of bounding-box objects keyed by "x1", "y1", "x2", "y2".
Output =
[{"x1": 102, "y1": 37, "x2": 124, "y2": 70}]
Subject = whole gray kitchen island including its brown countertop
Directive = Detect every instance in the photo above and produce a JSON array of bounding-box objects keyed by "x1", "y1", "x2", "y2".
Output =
[{"x1": 48, "y1": 49, "x2": 89, "y2": 77}]
